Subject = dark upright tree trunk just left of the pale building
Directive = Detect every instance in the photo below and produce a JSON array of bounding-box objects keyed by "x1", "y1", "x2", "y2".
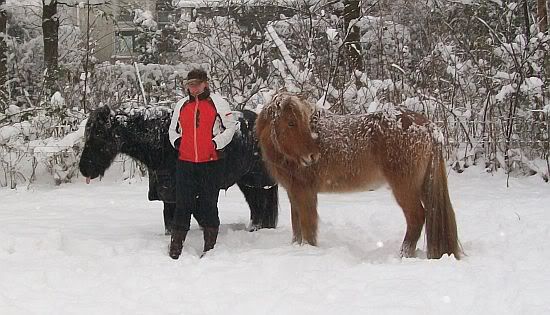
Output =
[{"x1": 42, "y1": 0, "x2": 59, "y2": 94}]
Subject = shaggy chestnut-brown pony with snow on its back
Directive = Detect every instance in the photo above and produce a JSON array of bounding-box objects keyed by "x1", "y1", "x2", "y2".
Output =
[{"x1": 256, "y1": 92, "x2": 461, "y2": 259}]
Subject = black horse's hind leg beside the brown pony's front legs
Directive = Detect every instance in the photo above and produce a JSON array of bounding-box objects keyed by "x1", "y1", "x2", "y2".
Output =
[{"x1": 237, "y1": 182, "x2": 279, "y2": 231}]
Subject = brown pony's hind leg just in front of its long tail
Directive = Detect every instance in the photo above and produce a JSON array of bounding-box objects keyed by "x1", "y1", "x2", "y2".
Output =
[{"x1": 390, "y1": 181, "x2": 426, "y2": 257}]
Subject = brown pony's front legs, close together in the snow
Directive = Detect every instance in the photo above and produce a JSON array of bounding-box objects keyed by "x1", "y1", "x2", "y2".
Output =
[{"x1": 288, "y1": 187, "x2": 318, "y2": 246}]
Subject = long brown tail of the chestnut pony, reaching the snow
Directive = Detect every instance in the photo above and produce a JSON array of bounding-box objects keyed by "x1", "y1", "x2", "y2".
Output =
[{"x1": 422, "y1": 146, "x2": 462, "y2": 259}]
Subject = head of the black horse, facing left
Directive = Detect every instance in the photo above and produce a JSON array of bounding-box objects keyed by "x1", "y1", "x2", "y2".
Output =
[{"x1": 79, "y1": 106, "x2": 119, "y2": 179}]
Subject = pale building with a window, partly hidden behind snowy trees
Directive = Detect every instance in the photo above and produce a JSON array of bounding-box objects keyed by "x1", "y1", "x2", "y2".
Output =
[{"x1": 74, "y1": 0, "x2": 295, "y2": 63}]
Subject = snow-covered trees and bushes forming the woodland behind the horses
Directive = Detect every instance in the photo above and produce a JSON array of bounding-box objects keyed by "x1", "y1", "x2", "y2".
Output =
[{"x1": 0, "y1": 0, "x2": 550, "y2": 188}]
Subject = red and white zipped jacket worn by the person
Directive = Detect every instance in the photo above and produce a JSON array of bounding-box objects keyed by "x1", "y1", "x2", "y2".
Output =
[{"x1": 168, "y1": 90, "x2": 239, "y2": 163}]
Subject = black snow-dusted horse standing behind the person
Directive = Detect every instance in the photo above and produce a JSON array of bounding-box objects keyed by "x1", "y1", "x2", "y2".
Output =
[{"x1": 79, "y1": 106, "x2": 279, "y2": 234}]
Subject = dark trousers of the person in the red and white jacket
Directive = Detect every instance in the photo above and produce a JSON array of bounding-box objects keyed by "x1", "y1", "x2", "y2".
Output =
[{"x1": 172, "y1": 160, "x2": 222, "y2": 231}]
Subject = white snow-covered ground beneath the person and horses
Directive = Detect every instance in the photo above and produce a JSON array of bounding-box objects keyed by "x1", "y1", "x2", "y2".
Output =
[{"x1": 0, "y1": 169, "x2": 550, "y2": 315}]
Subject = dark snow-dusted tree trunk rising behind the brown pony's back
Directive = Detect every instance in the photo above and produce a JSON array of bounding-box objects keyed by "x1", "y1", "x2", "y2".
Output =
[{"x1": 344, "y1": 0, "x2": 363, "y2": 73}]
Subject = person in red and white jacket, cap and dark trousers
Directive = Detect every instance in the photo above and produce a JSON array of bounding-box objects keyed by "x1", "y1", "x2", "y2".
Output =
[{"x1": 168, "y1": 69, "x2": 238, "y2": 259}]
